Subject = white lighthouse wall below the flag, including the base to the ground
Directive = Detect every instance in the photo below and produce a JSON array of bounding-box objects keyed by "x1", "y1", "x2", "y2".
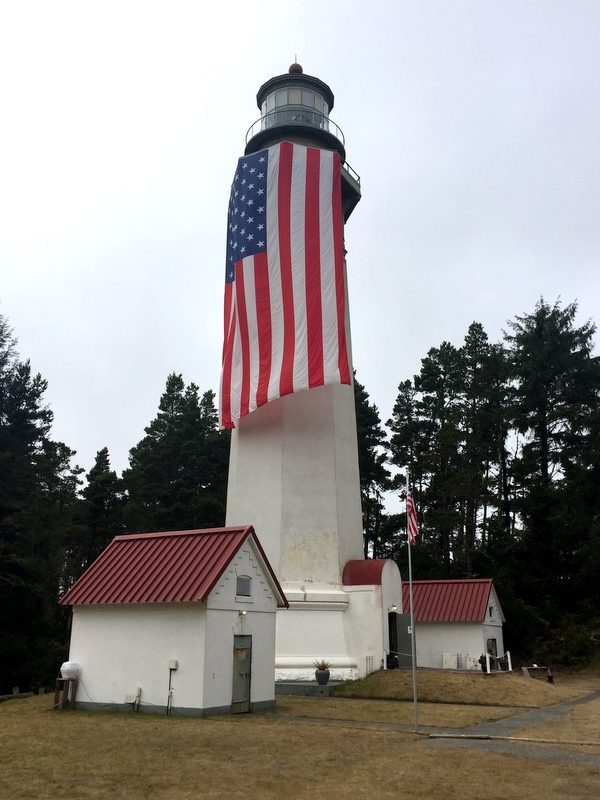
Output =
[{"x1": 226, "y1": 385, "x2": 380, "y2": 680}]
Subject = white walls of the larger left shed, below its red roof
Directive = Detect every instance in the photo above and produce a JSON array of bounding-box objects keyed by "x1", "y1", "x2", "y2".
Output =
[{"x1": 69, "y1": 540, "x2": 277, "y2": 713}]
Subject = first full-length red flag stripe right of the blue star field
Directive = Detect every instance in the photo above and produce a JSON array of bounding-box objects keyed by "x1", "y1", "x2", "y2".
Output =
[{"x1": 277, "y1": 142, "x2": 296, "y2": 397}]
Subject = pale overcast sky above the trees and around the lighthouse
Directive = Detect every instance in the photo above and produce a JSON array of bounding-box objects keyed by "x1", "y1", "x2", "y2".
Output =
[{"x1": 0, "y1": 0, "x2": 600, "y2": 472}]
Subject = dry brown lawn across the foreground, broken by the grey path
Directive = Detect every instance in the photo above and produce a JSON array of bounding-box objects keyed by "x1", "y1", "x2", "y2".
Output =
[{"x1": 0, "y1": 676, "x2": 600, "y2": 800}]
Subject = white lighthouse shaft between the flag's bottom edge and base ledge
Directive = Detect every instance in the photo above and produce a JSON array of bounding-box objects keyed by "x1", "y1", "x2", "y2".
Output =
[{"x1": 226, "y1": 385, "x2": 362, "y2": 585}]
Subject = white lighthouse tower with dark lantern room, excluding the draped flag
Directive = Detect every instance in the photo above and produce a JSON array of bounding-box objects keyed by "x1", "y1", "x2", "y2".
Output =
[{"x1": 226, "y1": 64, "x2": 402, "y2": 680}]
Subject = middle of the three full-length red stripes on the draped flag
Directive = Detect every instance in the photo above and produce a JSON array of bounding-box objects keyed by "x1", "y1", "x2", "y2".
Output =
[{"x1": 304, "y1": 148, "x2": 325, "y2": 388}]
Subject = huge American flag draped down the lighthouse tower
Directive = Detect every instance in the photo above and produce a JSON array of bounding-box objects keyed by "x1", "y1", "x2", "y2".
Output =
[{"x1": 219, "y1": 142, "x2": 351, "y2": 428}]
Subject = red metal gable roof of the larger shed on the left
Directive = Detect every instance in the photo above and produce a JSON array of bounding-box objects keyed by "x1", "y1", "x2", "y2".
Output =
[{"x1": 60, "y1": 525, "x2": 288, "y2": 607}]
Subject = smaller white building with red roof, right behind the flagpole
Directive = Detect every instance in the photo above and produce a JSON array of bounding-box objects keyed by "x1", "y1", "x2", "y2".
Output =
[{"x1": 402, "y1": 578, "x2": 505, "y2": 669}]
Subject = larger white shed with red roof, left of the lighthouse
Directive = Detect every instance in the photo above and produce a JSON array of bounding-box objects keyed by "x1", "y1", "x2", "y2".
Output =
[{"x1": 60, "y1": 526, "x2": 288, "y2": 716}]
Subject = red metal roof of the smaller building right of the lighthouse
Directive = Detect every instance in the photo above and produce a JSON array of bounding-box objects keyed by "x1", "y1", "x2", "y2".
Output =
[{"x1": 402, "y1": 578, "x2": 492, "y2": 622}]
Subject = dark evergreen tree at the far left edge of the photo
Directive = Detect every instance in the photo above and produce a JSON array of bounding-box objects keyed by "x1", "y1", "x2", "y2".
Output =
[{"x1": 0, "y1": 317, "x2": 81, "y2": 693}]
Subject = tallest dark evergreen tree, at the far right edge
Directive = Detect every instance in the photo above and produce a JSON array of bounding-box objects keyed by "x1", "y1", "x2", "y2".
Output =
[{"x1": 506, "y1": 299, "x2": 600, "y2": 624}]
